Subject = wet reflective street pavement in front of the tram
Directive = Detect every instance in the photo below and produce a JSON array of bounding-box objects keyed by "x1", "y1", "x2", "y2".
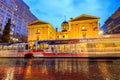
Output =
[{"x1": 0, "y1": 58, "x2": 120, "y2": 80}]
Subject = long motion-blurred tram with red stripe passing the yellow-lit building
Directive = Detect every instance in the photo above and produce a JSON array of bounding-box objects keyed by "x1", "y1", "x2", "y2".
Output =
[{"x1": 0, "y1": 35, "x2": 120, "y2": 57}]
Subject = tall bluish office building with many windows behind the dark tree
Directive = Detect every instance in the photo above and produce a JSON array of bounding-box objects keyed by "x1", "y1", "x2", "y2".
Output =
[{"x1": 0, "y1": 0, "x2": 37, "y2": 42}]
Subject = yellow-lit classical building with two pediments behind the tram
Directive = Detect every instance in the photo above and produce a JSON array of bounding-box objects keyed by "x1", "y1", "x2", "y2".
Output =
[{"x1": 28, "y1": 14, "x2": 100, "y2": 46}]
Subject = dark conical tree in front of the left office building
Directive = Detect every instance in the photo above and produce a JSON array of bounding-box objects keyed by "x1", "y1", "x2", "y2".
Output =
[{"x1": 2, "y1": 19, "x2": 11, "y2": 43}]
